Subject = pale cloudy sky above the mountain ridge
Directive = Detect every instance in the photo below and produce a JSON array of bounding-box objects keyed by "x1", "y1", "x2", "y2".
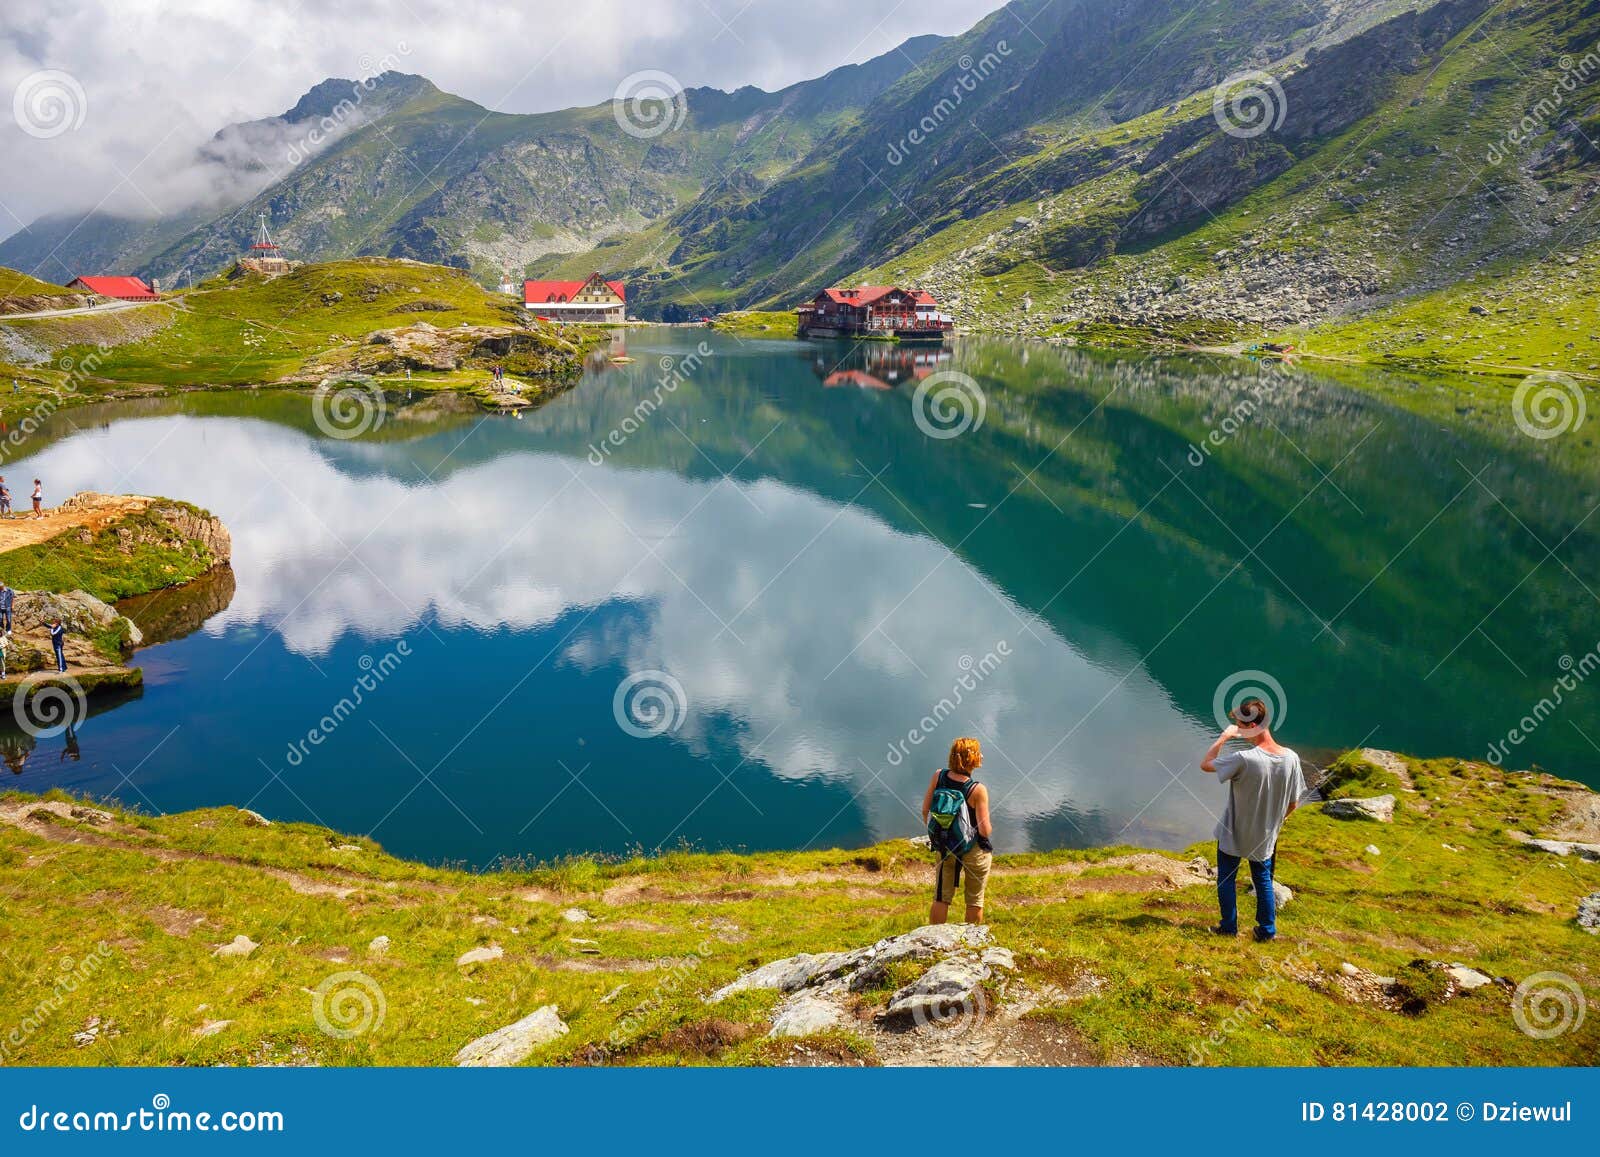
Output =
[{"x1": 0, "y1": 0, "x2": 1002, "y2": 237}]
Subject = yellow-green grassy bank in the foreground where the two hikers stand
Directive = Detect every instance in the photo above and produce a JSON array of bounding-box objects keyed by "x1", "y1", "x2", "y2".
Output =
[{"x1": 0, "y1": 759, "x2": 1600, "y2": 1064}]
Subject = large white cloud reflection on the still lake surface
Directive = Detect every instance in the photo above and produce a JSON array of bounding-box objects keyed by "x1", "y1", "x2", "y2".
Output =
[{"x1": 27, "y1": 403, "x2": 1211, "y2": 848}]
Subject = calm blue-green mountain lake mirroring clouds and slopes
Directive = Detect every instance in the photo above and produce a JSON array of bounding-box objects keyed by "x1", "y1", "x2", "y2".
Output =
[{"x1": 12, "y1": 331, "x2": 1600, "y2": 863}]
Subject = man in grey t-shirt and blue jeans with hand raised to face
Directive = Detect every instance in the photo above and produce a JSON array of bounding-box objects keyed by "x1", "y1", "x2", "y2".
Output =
[{"x1": 1200, "y1": 699, "x2": 1306, "y2": 939}]
